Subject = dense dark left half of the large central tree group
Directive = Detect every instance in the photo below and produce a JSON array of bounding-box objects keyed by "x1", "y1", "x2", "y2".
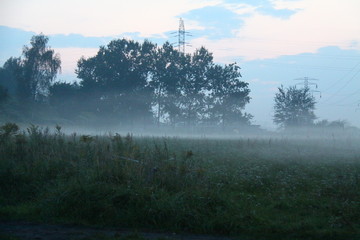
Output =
[{"x1": 76, "y1": 39, "x2": 156, "y2": 124}]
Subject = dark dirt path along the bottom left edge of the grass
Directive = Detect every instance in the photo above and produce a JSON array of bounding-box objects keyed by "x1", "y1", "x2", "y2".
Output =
[{"x1": 0, "y1": 221, "x2": 236, "y2": 240}]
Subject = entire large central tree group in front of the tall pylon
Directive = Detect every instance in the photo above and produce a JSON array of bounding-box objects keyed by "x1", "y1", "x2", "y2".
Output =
[{"x1": 77, "y1": 39, "x2": 251, "y2": 126}]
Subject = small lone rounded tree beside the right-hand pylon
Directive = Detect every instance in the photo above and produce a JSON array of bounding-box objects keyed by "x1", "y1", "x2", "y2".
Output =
[{"x1": 273, "y1": 86, "x2": 316, "y2": 128}]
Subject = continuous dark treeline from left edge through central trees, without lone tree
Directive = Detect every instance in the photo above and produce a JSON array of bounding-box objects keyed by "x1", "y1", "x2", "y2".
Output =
[{"x1": 0, "y1": 35, "x2": 252, "y2": 126}]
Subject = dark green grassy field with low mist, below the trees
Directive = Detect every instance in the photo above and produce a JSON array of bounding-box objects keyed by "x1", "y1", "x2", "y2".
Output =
[{"x1": 0, "y1": 124, "x2": 360, "y2": 239}]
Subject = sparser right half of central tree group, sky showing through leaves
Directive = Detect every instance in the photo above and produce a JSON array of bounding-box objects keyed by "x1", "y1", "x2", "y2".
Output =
[{"x1": 151, "y1": 43, "x2": 251, "y2": 125}]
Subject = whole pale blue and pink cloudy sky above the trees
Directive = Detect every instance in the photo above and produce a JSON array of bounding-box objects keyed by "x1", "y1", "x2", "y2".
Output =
[{"x1": 0, "y1": 0, "x2": 360, "y2": 129}]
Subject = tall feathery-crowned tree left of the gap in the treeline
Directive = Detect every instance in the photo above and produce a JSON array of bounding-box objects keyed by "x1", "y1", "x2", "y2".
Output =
[{"x1": 16, "y1": 34, "x2": 61, "y2": 102}]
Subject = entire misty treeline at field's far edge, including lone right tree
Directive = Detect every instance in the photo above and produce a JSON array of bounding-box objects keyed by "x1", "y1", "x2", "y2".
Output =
[{"x1": 0, "y1": 35, "x2": 359, "y2": 138}]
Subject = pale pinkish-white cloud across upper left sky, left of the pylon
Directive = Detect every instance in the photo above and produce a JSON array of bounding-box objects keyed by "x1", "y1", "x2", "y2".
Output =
[{"x1": 0, "y1": 0, "x2": 220, "y2": 37}]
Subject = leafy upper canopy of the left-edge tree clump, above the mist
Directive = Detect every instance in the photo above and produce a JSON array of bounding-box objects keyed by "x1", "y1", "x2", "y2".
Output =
[{"x1": 0, "y1": 34, "x2": 61, "y2": 102}]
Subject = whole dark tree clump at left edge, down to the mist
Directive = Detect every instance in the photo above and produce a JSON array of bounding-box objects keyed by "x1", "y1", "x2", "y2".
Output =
[{"x1": 0, "y1": 34, "x2": 61, "y2": 124}]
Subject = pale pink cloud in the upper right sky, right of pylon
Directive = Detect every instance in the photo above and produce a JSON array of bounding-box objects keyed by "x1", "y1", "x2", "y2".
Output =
[{"x1": 191, "y1": 0, "x2": 360, "y2": 62}]
